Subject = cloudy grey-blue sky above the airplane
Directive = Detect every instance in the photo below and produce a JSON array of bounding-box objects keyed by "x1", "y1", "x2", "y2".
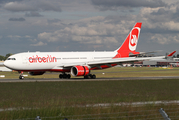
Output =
[{"x1": 0, "y1": 0, "x2": 179, "y2": 55}]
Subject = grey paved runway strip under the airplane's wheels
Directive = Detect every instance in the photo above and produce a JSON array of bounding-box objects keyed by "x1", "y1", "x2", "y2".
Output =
[{"x1": 0, "y1": 76, "x2": 179, "y2": 82}]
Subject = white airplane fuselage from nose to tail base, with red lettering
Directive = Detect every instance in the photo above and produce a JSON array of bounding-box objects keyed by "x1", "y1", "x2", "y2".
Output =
[{"x1": 4, "y1": 51, "x2": 117, "y2": 72}]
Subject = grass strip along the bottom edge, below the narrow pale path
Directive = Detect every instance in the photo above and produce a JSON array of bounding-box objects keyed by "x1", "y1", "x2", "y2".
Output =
[{"x1": 0, "y1": 105, "x2": 179, "y2": 120}]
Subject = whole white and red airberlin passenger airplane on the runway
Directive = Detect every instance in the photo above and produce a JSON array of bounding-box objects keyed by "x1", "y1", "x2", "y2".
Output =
[{"x1": 4, "y1": 22, "x2": 174, "y2": 79}]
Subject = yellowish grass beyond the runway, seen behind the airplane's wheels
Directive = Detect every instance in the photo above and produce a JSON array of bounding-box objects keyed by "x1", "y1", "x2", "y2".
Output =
[{"x1": 0, "y1": 67, "x2": 179, "y2": 79}]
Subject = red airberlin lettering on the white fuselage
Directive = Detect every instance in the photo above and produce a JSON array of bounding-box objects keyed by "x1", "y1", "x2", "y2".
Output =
[{"x1": 28, "y1": 55, "x2": 57, "y2": 63}]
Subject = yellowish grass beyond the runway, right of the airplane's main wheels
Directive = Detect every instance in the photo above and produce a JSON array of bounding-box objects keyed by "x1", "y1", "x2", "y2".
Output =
[{"x1": 92, "y1": 67, "x2": 179, "y2": 78}]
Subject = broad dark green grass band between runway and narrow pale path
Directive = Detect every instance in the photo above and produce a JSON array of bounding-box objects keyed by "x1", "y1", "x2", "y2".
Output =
[{"x1": 0, "y1": 80, "x2": 179, "y2": 109}]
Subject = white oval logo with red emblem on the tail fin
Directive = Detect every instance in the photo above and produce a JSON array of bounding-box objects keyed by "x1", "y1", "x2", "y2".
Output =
[{"x1": 129, "y1": 27, "x2": 140, "y2": 51}]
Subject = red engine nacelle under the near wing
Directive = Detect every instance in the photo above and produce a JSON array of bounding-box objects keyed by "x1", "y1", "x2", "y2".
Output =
[{"x1": 71, "y1": 66, "x2": 90, "y2": 76}]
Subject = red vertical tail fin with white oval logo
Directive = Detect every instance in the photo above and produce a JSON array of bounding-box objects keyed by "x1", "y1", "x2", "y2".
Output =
[{"x1": 114, "y1": 22, "x2": 142, "y2": 58}]
